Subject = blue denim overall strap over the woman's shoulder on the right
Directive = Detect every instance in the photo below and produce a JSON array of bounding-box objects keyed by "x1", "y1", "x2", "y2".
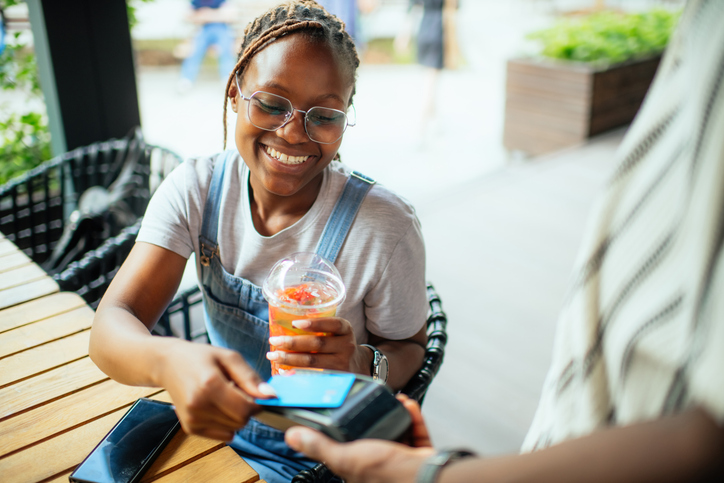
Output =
[{"x1": 315, "y1": 171, "x2": 375, "y2": 263}]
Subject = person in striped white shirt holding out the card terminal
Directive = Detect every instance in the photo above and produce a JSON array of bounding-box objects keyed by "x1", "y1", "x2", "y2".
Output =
[{"x1": 286, "y1": 0, "x2": 724, "y2": 483}]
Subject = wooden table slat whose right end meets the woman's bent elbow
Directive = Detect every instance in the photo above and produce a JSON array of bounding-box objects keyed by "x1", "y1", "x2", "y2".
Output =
[{"x1": 0, "y1": 330, "x2": 90, "y2": 387}]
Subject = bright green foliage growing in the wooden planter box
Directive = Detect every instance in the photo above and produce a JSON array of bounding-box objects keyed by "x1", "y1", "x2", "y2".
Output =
[{"x1": 528, "y1": 9, "x2": 681, "y2": 64}]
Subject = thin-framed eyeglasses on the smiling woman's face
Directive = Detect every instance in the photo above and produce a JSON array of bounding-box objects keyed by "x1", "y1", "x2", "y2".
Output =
[{"x1": 236, "y1": 77, "x2": 355, "y2": 144}]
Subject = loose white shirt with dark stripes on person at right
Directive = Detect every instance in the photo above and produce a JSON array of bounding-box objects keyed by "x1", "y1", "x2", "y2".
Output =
[{"x1": 523, "y1": 0, "x2": 724, "y2": 451}]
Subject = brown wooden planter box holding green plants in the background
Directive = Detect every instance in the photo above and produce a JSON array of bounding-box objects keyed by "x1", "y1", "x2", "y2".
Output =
[{"x1": 503, "y1": 56, "x2": 661, "y2": 156}]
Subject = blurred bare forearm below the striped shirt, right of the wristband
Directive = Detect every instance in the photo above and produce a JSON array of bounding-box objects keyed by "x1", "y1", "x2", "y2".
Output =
[{"x1": 439, "y1": 409, "x2": 724, "y2": 483}]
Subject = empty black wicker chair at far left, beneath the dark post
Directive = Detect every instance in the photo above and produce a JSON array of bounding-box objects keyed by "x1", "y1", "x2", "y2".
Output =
[{"x1": 0, "y1": 128, "x2": 180, "y2": 275}]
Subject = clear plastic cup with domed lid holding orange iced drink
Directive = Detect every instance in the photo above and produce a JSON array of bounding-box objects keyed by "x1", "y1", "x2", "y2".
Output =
[{"x1": 262, "y1": 252, "x2": 346, "y2": 375}]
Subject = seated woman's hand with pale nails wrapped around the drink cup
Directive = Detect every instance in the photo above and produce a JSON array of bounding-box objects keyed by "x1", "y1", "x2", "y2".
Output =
[{"x1": 267, "y1": 317, "x2": 372, "y2": 375}]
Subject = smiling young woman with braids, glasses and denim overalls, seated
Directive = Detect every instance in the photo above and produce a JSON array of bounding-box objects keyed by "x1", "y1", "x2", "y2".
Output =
[{"x1": 90, "y1": 0, "x2": 427, "y2": 483}]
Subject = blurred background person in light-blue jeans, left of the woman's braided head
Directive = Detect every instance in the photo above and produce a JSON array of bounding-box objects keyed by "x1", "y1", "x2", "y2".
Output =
[{"x1": 178, "y1": 0, "x2": 236, "y2": 93}]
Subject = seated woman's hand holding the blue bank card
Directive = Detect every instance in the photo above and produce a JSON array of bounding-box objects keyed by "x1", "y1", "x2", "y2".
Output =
[{"x1": 159, "y1": 341, "x2": 274, "y2": 441}]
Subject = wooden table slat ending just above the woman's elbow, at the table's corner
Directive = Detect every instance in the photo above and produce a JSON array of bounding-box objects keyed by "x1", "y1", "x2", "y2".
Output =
[{"x1": 0, "y1": 305, "x2": 95, "y2": 359}]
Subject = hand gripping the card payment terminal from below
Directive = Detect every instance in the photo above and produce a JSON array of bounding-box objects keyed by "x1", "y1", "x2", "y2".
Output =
[{"x1": 285, "y1": 395, "x2": 434, "y2": 483}]
